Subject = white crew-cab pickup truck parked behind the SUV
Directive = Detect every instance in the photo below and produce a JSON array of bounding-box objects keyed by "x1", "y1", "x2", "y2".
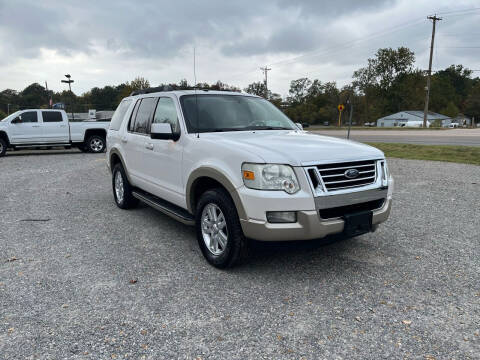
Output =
[{"x1": 0, "y1": 109, "x2": 110, "y2": 157}]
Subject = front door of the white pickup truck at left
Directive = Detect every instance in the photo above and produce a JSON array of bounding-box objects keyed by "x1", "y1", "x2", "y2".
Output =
[{"x1": 8, "y1": 110, "x2": 44, "y2": 145}]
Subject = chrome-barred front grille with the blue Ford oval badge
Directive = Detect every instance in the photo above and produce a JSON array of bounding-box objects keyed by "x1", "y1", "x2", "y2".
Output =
[{"x1": 316, "y1": 160, "x2": 377, "y2": 191}]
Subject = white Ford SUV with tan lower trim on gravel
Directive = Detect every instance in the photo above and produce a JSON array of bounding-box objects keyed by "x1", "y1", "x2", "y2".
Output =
[{"x1": 107, "y1": 88, "x2": 393, "y2": 268}]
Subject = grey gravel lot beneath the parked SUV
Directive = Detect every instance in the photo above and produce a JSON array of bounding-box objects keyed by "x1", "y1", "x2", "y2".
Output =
[{"x1": 0, "y1": 152, "x2": 480, "y2": 359}]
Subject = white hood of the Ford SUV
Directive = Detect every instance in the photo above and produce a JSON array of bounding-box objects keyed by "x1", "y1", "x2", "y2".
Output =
[{"x1": 200, "y1": 130, "x2": 384, "y2": 166}]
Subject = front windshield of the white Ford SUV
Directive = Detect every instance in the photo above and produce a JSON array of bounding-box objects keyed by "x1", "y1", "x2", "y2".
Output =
[{"x1": 180, "y1": 94, "x2": 298, "y2": 133}]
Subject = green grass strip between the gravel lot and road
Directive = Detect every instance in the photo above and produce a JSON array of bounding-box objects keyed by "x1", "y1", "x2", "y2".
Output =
[{"x1": 368, "y1": 143, "x2": 480, "y2": 165}]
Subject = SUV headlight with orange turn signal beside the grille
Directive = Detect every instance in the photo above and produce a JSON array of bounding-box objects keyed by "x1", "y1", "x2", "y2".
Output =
[{"x1": 242, "y1": 163, "x2": 300, "y2": 194}]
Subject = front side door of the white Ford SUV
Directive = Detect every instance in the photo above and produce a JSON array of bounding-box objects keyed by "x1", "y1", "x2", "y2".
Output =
[{"x1": 141, "y1": 96, "x2": 185, "y2": 206}]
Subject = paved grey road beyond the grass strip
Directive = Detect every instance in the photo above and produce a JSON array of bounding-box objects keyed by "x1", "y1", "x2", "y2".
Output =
[{"x1": 312, "y1": 129, "x2": 480, "y2": 146}]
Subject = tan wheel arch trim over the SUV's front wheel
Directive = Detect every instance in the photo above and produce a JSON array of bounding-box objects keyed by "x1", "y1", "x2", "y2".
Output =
[{"x1": 185, "y1": 167, "x2": 247, "y2": 219}]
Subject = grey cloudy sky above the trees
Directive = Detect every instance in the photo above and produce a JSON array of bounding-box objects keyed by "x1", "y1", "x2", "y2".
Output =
[{"x1": 0, "y1": 0, "x2": 480, "y2": 95}]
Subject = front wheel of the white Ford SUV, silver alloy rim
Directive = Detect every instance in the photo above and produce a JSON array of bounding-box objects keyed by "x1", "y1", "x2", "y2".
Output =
[{"x1": 195, "y1": 188, "x2": 247, "y2": 268}]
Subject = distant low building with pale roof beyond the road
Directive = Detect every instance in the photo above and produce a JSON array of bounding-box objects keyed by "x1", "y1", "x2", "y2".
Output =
[{"x1": 377, "y1": 110, "x2": 452, "y2": 127}]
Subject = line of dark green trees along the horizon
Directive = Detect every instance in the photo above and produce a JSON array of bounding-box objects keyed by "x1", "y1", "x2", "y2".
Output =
[{"x1": 0, "y1": 47, "x2": 480, "y2": 124}]
